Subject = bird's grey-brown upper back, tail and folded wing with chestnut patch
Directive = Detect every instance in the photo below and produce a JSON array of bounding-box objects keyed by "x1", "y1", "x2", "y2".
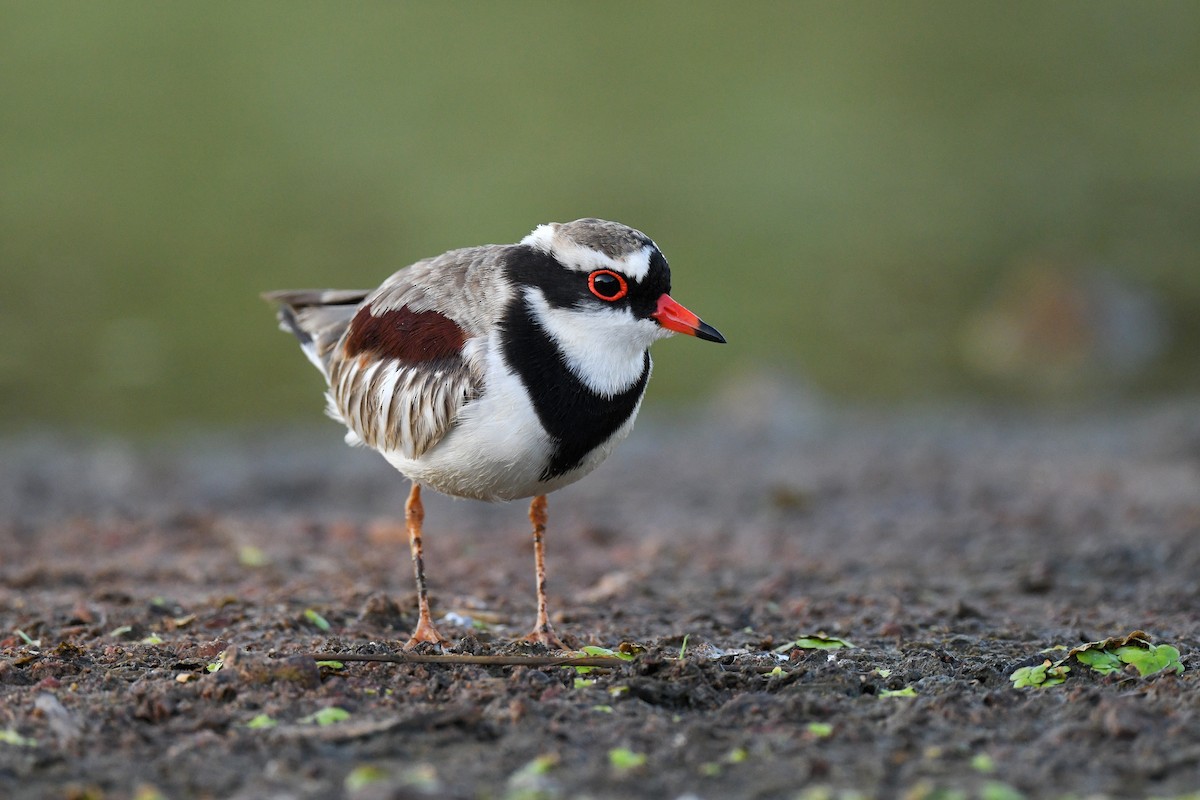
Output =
[{"x1": 264, "y1": 245, "x2": 509, "y2": 458}]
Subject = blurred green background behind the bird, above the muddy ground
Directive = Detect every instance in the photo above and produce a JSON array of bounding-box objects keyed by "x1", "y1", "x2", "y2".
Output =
[{"x1": 0, "y1": 1, "x2": 1200, "y2": 433}]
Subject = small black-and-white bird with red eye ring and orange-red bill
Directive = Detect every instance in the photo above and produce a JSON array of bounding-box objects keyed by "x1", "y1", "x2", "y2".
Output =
[{"x1": 262, "y1": 218, "x2": 726, "y2": 649}]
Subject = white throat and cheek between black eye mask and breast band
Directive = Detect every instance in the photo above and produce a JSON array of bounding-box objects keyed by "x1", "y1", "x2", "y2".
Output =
[{"x1": 524, "y1": 287, "x2": 671, "y2": 397}]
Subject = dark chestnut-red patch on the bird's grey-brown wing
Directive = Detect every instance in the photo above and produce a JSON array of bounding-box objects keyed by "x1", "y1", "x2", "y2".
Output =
[{"x1": 344, "y1": 305, "x2": 467, "y2": 363}]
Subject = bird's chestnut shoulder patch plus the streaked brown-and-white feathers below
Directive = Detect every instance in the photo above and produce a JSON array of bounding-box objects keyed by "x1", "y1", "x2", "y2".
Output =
[{"x1": 329, "y1": 306, "x2": 480, "y2": 458}]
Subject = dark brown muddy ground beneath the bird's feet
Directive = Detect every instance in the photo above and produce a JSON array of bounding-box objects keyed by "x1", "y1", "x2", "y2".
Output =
[{"x1": 0, "y1": 398, "x2": 1200, "y2": 800}]
